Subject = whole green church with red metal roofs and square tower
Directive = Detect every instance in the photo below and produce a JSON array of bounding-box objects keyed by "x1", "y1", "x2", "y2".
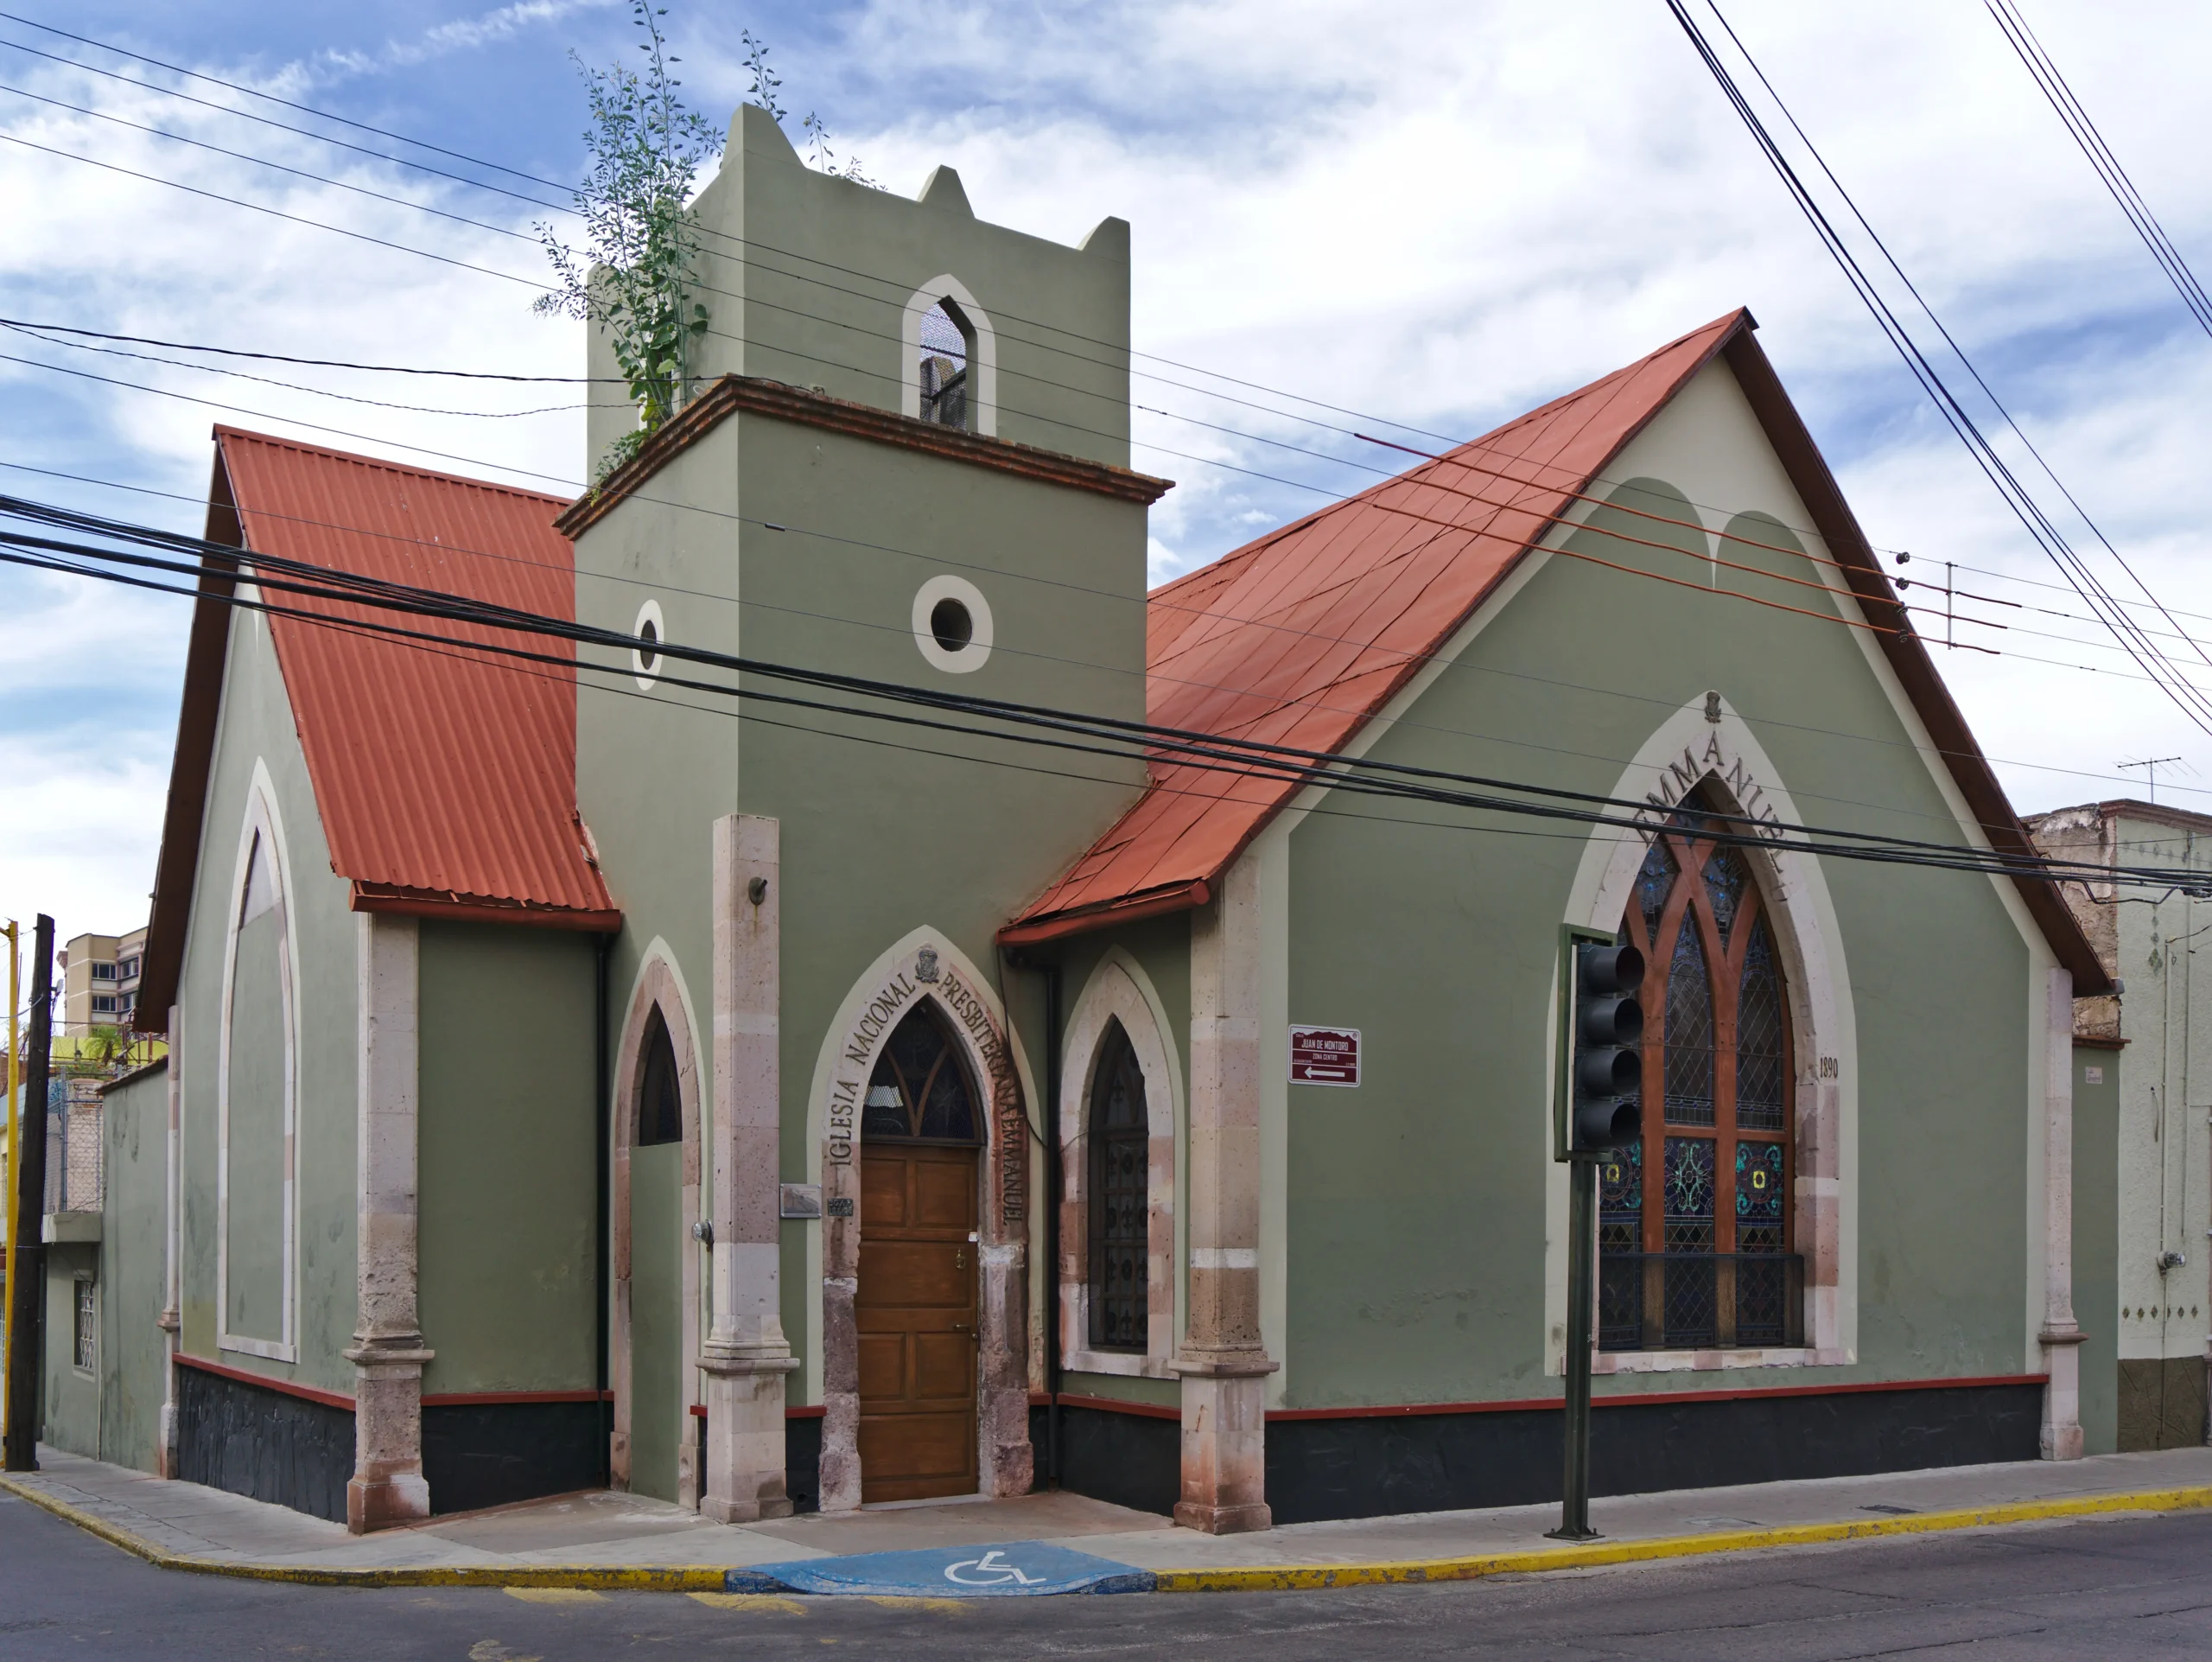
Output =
[{"x1": 81, "y1": 108, "x2": 2106, "y2": 1529}]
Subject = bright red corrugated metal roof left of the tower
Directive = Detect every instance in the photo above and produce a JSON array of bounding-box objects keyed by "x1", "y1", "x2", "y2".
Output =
[{"x1": 214, "y1": 427, "x2": 613, "y2": 927}]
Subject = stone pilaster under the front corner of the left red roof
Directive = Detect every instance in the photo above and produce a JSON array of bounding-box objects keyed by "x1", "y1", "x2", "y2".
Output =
[{"x1": 345, "y1": 912, "x2": 431, "y2": 1536}]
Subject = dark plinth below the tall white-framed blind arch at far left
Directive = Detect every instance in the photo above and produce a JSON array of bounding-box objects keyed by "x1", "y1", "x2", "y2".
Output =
[{"x1": 177, "y1": 1367, "x2": 354, "y2": 1523}]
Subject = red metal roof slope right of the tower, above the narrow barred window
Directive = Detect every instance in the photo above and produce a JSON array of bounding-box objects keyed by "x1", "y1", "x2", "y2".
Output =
[{"x1": 1004, "y1": 309, "x2": 1750, "y2": 939}]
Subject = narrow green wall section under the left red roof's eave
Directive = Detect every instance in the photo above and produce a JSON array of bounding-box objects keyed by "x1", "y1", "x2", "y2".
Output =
[{"x1": 416, "y1": 920, "x2": 597, "y2": 1394}]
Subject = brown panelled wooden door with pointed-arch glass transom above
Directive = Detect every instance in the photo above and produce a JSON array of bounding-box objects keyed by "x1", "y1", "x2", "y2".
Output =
[{"x1": 854, "y1": 998, "x2": 984, "y2": 1503}]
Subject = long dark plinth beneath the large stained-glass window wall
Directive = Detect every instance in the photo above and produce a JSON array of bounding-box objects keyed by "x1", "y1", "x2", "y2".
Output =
[{"x1": 1265, "y1": 1385, "x2": 2042, "y2": 1523}]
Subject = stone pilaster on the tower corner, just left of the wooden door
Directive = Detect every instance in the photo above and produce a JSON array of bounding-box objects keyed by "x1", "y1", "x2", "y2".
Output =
[{"x1": 699, "y1": 814, "x2": 798, "y2": 1523}]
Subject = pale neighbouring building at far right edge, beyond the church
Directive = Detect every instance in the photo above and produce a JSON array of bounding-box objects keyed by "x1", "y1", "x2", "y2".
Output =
[{"x1": 2029, "y1": 799, "x2": 2212, "y2": 1449}]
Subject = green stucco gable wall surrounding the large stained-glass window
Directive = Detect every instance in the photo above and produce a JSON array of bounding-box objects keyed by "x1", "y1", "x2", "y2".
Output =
[{"x1": 1269, "y1": 468, "x2": 2031, "y2": 1408}]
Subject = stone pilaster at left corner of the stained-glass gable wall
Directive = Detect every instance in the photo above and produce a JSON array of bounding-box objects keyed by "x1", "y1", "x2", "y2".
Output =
[{"x1": 1174, "y1": 854, "x2": 1276, "y2": 1536}]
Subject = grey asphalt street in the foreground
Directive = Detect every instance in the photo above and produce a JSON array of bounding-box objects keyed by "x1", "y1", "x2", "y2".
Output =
[{"x1": 0, "y1": 1496, "x2": 2212, "y2": 1662}]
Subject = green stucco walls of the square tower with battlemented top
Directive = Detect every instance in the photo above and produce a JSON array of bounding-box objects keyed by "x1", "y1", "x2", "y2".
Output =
[{"x1": 577, "y1": 137, "x2": 1159, "y2": 1401}]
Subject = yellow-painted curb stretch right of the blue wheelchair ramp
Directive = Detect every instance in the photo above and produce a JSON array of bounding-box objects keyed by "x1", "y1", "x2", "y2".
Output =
[{"x1": 1154, "y1": 1487, "x2": 2212, "y2": 1594}]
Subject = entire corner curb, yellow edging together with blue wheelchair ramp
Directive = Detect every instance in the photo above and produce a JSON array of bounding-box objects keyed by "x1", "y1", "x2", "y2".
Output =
[{"x1": 0, "y1": 1476, "x2": 2212, "y2": 1598}]
